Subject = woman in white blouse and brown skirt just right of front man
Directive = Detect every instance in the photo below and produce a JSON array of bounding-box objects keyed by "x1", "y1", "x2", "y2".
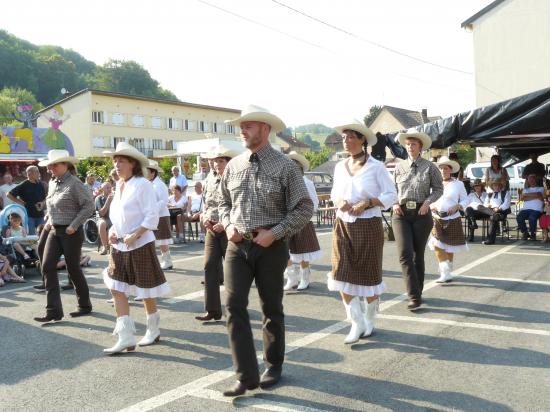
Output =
[{"x1": 328, "y1": 120, "x2": 397, "y2": 344}]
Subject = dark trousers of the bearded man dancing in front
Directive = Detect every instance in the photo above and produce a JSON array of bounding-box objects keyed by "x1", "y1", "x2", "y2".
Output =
[{"x1": 224, "y1": 239, "x2": 289, "y2": 384}]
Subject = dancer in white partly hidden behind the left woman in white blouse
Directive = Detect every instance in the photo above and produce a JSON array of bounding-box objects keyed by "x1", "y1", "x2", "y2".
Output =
[{"x1": 147, "y1": 160, "x2": 174, "y2": 270}]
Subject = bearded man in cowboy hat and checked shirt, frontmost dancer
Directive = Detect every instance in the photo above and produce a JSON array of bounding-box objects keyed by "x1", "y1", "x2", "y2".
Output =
[{"x1": 219, "y1": 106, "x2": 313, "y2": 396}]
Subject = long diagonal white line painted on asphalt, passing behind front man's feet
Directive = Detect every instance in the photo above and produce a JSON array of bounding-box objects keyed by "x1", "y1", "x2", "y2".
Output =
[{"x1": 116, "y1": 242, "x2": 522, "y2": 412}]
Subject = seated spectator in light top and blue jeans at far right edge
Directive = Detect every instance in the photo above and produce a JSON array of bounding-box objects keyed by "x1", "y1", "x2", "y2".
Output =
[{"x1": 516, "y1": 173, "x2": 544, "y2": 240}]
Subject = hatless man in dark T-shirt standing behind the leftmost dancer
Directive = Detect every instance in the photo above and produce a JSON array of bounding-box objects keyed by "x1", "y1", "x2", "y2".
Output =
[{"x1": 8, "y1": 166, "x2": 47, "y2": 235}]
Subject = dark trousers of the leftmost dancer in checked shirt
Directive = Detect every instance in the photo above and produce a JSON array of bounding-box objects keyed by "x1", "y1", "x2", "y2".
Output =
[{"x1": 40, "y1": 226, "x2": 92, "y2": 316}]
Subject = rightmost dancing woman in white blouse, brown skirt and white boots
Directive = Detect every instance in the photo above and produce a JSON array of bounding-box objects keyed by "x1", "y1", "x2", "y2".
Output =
[{"x1": 428, "y1": 156, "x2": 468, "y2": 283}]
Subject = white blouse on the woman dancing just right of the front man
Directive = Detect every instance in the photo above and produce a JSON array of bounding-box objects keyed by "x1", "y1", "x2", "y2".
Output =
[{"x1": 330, "y1": 156, "x2": 397, "y2": 222}]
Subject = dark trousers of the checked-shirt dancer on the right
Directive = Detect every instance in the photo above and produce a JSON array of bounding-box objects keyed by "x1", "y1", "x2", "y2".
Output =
[{"x1": 392, "y1": 207, "x2": 433, "y2": 300}]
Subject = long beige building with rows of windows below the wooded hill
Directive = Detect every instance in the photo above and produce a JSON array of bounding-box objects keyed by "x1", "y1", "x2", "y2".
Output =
[{"x1": 38, "y1": 89, "x2": 240, "y2": 158}]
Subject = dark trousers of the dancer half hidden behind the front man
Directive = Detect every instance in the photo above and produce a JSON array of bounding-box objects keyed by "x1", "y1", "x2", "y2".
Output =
[{"x1": 204, "y1": 230, "x2": 227, "y2": 315}]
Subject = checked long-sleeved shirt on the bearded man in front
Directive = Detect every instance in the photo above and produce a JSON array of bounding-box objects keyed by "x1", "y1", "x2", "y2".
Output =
[{"x1": 218, "y1": 144, "x2": 313, "y2": 239}]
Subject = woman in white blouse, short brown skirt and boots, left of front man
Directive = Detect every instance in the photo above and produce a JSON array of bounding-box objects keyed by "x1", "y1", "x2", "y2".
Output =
[{"x1": 103, "y1": 142, "x2": 170, "y2": 354}]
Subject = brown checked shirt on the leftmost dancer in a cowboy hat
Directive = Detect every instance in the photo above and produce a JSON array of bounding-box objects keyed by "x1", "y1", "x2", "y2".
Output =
[{"x1": 46, "y1": 172, "x2": 95, "y2": 230}]
